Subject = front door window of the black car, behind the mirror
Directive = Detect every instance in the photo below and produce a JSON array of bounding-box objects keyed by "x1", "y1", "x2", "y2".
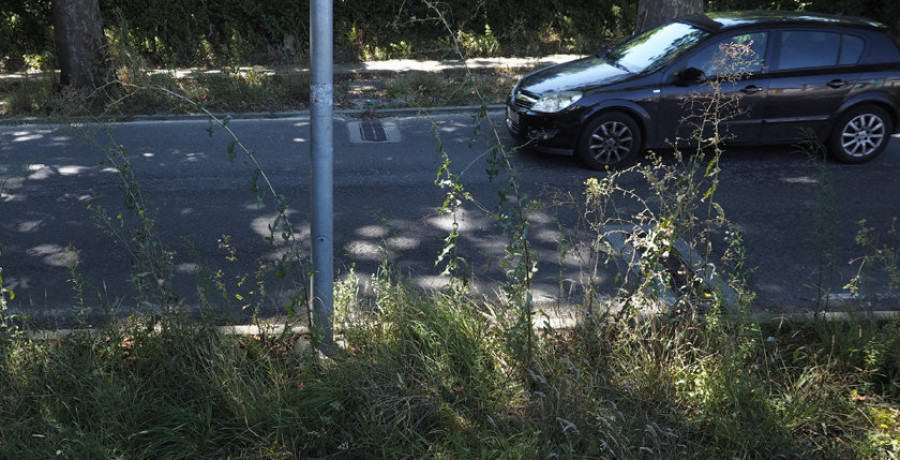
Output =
[{"x1": 687, "y1": 32, "x2": 768, "y2": 77}]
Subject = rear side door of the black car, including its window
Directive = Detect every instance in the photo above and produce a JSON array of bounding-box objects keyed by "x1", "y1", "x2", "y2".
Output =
[{"x1": 763, "y1": 29, "x2": 864, "y2": 141}]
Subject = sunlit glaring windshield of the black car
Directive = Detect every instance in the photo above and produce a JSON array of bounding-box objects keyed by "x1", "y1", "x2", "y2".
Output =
[{"x1": 606, "y1": 22, "x2": 710, "y2": 73}]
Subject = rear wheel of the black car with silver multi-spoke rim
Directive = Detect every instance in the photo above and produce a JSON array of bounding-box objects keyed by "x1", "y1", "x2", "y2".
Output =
[{"x1": 828, "y1": 105, "x2": 894, "y2": 164}]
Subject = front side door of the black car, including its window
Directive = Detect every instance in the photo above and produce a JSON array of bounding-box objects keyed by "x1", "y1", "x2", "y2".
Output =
[{"x1": 658, "y1": 30, "x2": 769, "y2": 146}]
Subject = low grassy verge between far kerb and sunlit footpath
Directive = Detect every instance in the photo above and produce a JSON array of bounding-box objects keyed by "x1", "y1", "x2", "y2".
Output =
[{"x1": 0, "y1": 65, "x2": 528, "y2": 117}]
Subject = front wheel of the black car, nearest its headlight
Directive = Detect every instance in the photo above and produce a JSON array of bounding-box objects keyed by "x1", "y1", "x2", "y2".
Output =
[{"x1": 575, "y1": 112, "x2": 643, "y2": 170}]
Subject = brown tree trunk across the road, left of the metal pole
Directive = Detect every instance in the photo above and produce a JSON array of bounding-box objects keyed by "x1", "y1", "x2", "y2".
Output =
[{"x1": 53, "y1": 0, "x2": 110, "y2": 89}]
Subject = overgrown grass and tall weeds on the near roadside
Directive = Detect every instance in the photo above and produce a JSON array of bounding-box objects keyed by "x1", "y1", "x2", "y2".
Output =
[{"x1": 0, "y1": 4, "x2": 900, "y2": 459}]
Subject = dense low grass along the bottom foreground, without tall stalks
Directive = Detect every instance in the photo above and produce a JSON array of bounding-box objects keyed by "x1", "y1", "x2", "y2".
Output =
[{"x1": 0, "y1": 279, "x2": 900, "y2": 458}]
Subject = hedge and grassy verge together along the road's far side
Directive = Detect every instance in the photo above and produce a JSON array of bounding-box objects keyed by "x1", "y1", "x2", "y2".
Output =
[{"x1": 0, "y1": 0, "x2": 900, "y2": 118}]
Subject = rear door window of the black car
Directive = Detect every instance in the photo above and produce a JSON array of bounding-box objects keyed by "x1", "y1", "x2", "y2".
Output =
[{"x1": 778, "y1": 30, "x2": 840, "y2": 70}]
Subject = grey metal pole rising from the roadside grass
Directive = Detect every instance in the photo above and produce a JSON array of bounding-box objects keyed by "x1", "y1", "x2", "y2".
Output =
[{"x1": 309, "y1": 0, "x2": 334, "y2": 355}]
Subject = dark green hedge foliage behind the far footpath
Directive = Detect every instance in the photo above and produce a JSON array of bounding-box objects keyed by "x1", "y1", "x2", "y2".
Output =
[{"x1": 0, "y1": 0, "x2": 900, "y2": 72}]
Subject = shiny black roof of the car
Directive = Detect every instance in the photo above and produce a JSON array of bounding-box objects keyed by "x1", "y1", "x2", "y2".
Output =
[{"x1": 680, "y1": 10, "x2": 886, "y2": 31}]
